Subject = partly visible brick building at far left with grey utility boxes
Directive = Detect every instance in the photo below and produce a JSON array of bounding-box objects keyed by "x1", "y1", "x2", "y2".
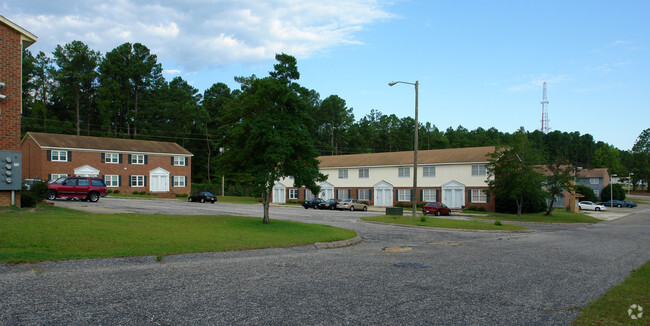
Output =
[{"x1": 0, "y1": 16, "x2": 36, "y2": 206}]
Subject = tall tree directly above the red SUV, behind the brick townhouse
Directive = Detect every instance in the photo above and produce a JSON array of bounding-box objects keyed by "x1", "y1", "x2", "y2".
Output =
[{"x1": 53, "y1": 41, "x2": 101, "y2": 136}]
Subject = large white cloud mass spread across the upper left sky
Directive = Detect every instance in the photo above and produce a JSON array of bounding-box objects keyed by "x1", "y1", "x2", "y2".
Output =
[{"x1": 3, "y1": 0, "x2": 395, "y2": 71}]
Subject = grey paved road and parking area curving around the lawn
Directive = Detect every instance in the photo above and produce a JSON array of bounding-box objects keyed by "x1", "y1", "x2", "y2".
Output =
[{"x1": 0, "y1": 198, "x2": 650, "y2": 325}]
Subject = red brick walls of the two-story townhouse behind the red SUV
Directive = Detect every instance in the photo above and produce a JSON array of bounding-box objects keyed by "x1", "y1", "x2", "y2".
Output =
[{"x1": 22, "y1": 138, "x2": 192, "y2": 194}]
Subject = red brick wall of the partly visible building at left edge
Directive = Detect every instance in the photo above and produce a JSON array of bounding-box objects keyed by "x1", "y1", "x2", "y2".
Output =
[{"x1": 0, "y1": 23, "x2": 22, "y2": 207}]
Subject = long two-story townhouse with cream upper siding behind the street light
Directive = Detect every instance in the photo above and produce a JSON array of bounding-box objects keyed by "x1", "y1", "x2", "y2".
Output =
[{"x1": 272, "y1": 146, "x2": 495, "y2": 211}]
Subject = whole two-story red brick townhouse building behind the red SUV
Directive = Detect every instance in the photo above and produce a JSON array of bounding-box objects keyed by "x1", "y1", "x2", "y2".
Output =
[{"x1": 21, "y1": 132, "x2": 193, "y2": 196}]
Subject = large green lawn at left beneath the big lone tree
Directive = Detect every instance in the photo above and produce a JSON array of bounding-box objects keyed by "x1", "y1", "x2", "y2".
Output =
[{"x1": 0, "y1": 206, "x2": 356, "y2": 264}]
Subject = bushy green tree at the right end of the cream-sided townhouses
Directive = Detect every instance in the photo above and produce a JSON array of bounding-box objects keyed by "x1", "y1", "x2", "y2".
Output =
[{"x1": 486, "y1": 127, "x2": 543, "y2": 217}]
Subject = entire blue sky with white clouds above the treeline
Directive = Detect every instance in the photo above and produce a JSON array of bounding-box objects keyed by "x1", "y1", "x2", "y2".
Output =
[{"x1": 0, "y1": 0, "x2": 650, "y2": 150}]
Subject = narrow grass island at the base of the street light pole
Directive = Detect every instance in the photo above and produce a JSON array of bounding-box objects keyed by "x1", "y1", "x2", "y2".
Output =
[{"x1": 361, "y1": 215, "x2": 528, "y2": 231}]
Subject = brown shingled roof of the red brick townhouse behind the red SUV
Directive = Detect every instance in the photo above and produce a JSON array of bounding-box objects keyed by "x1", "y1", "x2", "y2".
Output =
[{"x1": 22, "y1": 132, "x2": 192, "y2": 156}]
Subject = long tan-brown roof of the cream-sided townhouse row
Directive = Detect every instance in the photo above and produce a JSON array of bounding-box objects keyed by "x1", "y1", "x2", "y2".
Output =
[{"x1": 318, "y1": 146, "x2": 495, "y2": 168}]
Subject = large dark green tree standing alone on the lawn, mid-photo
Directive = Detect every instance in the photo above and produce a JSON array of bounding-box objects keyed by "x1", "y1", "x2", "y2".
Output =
[{"x1": 221, "y1": 54, "x2": 325, "y2": 224}]
